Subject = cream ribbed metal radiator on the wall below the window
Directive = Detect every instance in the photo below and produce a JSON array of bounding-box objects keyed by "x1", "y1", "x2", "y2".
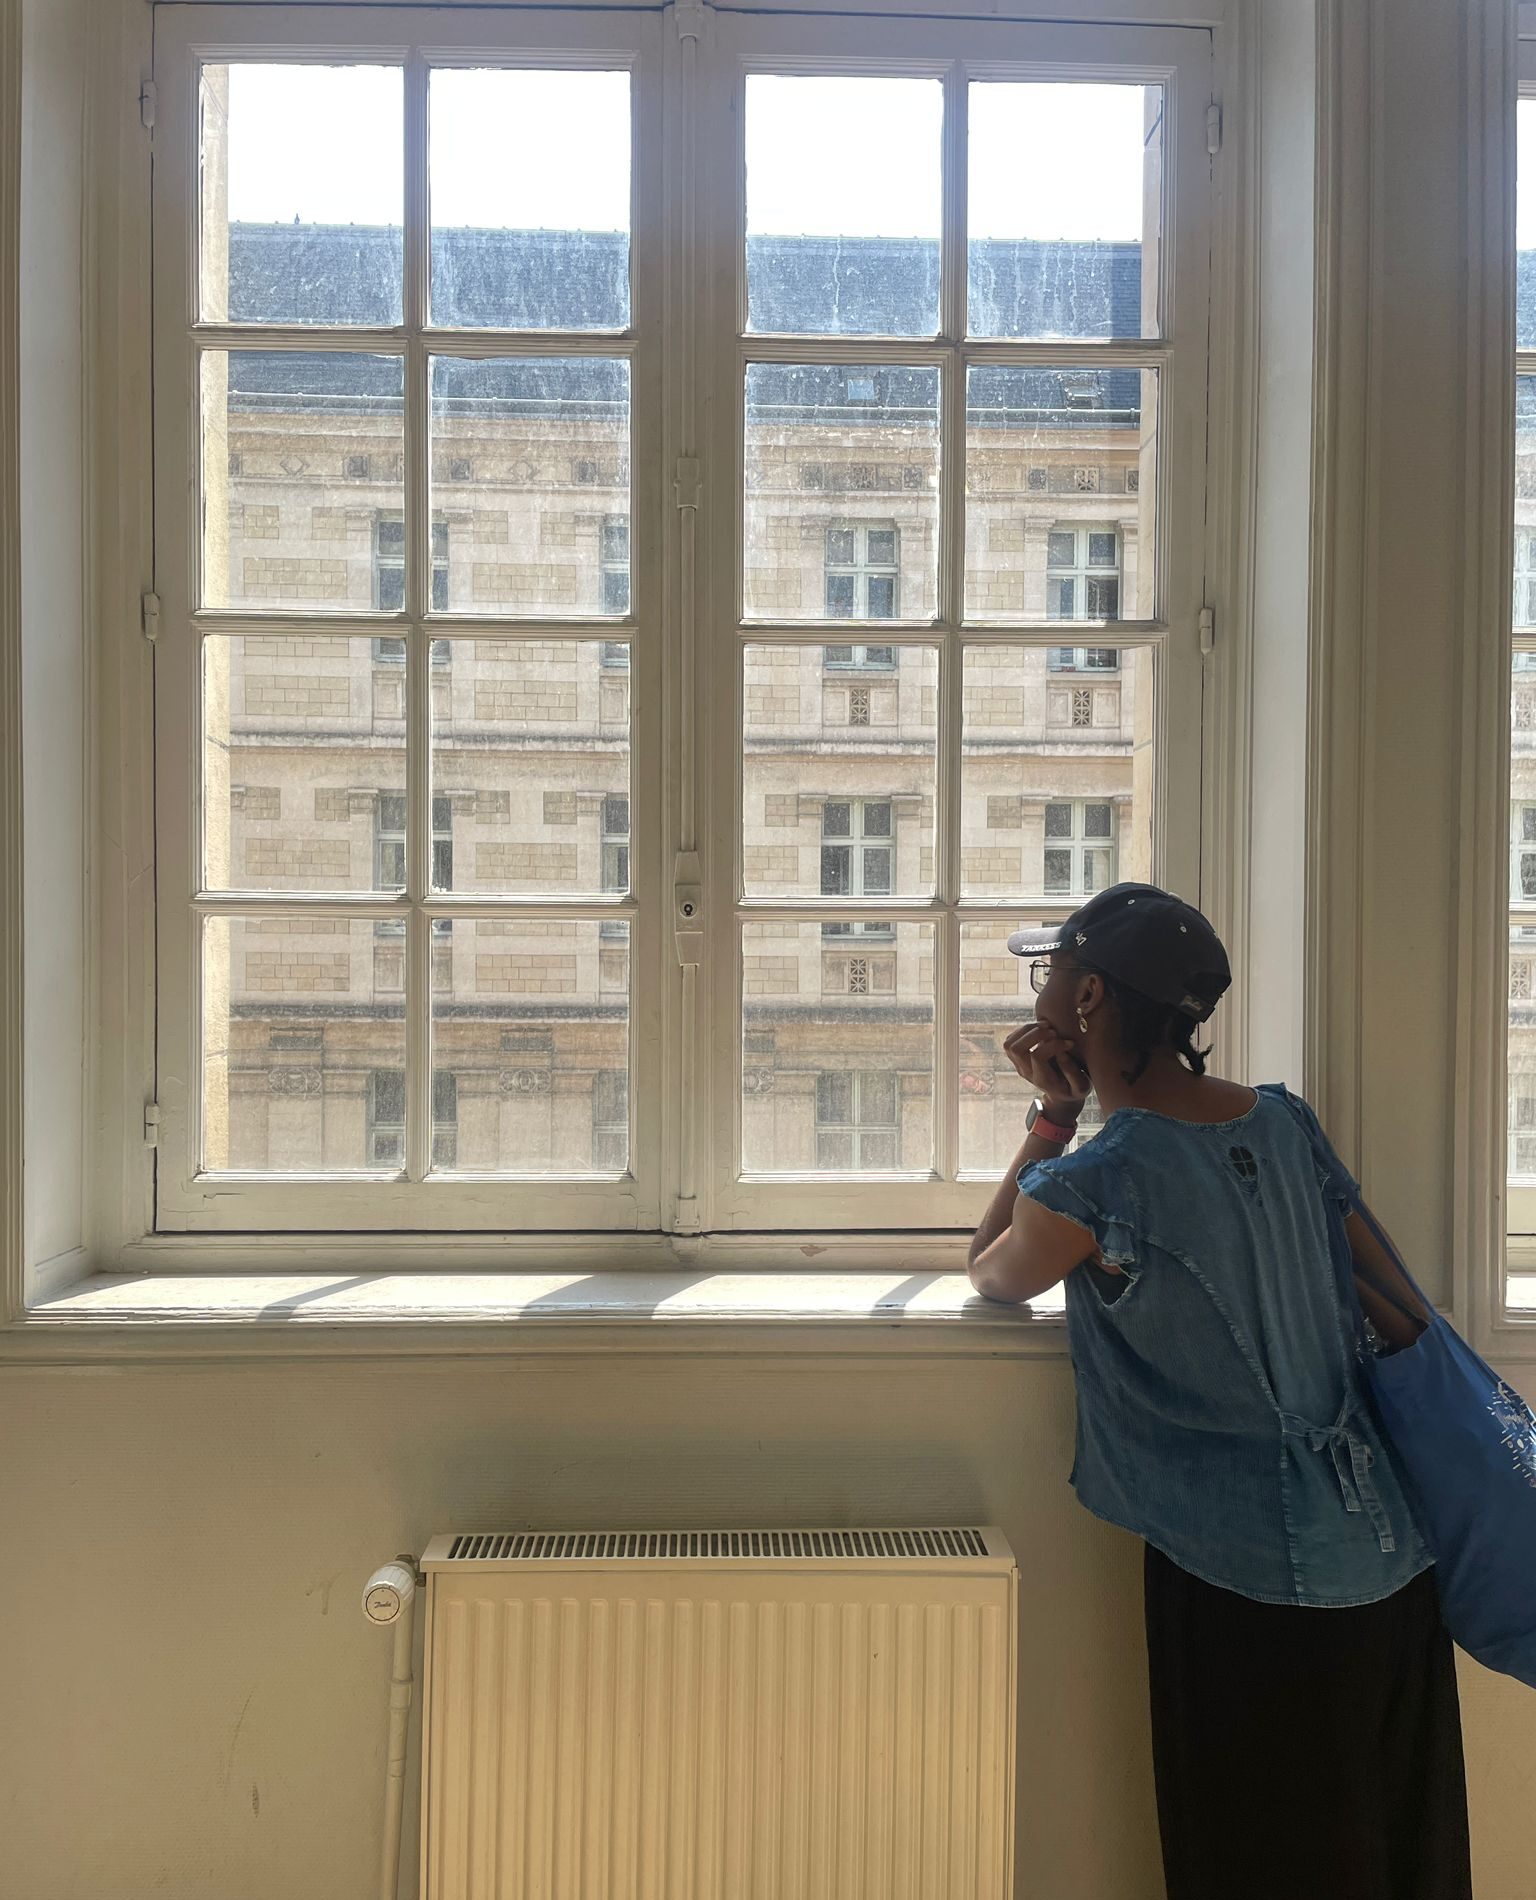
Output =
[{"x1": 422, "y1": 1530, "x2": 1019, "y2": 1900}]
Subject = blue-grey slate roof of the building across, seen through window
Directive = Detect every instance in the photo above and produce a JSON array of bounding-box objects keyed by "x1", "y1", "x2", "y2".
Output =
[{"x1": 230, "y1": 224, "x2": 1141, "y2": 429}]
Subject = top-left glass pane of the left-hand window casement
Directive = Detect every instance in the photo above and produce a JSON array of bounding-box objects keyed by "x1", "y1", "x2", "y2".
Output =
[{"x1": 200, "y1": 61, "x2": 405, "y2": 325}]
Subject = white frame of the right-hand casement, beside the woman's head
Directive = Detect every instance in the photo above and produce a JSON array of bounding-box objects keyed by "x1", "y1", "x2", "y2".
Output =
[{"x1": 703, "y1": 13, "x2": 1213, "y2": 1231}]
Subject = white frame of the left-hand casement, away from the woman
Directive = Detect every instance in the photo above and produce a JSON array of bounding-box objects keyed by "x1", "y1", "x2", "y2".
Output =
[{"x1": 154, "y1": 6, "x2": 665, "y2": 1239}]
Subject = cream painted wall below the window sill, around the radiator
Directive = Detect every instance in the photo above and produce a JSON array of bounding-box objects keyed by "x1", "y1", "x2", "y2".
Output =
[{"x1": 0, "y1": 1357, "x2": 1536, "y2": 1900}]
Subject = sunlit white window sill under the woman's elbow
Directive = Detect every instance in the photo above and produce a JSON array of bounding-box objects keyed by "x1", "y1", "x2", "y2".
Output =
[{"x1": 0, "y1": 1269, "x2": 1065, "y2": 1360}]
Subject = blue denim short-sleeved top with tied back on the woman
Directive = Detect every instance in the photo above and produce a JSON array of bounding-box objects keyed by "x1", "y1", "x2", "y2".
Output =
[{"x1": 1019, "y1": 1087, "x2": 1430, "y2": 1606}]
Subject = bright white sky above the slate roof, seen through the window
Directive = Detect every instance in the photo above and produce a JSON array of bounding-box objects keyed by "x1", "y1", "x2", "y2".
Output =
[{"x1": 228, "y1": 65, "x2": 1148, "y2": 238}]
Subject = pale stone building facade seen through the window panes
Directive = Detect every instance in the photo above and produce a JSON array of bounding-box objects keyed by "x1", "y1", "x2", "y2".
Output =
[{"x1": 203, "y1": 228, "x2": 1156, "y2": 1174}]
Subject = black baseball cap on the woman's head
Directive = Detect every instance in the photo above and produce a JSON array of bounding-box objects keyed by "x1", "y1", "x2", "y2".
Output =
[{"x1": 1008, "y1": 884, "x2": 1232, "y2": 1022}]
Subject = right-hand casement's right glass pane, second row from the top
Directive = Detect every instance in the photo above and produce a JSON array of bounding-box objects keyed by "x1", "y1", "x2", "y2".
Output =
[{"x1": 966, "y1": 365, "x2": 1158, "y2": 621}]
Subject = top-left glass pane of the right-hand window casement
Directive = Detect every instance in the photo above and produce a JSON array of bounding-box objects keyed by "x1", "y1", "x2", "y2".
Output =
[{"x1": 745, "y1": 72, "x2": 943, "y2": 336}]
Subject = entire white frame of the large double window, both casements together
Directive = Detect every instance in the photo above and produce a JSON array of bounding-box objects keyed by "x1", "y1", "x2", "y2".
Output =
[{"x1": 132, "y1": 8, "x2": 1211, "y2": 1233}]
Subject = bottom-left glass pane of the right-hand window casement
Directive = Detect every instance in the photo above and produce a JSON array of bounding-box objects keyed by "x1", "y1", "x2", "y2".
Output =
[{"x1": 741, "y1": 923, "x2": 933, "y2": 1174}]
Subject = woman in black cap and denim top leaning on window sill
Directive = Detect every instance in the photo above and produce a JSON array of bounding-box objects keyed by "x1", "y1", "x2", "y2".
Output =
[{"x1": 970, "y1": 884, "x2": 1471, "y2": 1900}]
